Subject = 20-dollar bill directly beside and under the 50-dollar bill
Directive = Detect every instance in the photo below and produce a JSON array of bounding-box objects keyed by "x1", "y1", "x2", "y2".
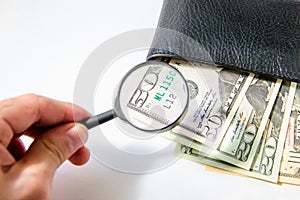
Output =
[{"x1": 214, "y1": 77, "x2": 282, "y2": 170}]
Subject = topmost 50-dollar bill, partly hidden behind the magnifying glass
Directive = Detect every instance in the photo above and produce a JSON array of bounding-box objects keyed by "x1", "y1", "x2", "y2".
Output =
[{"x1": 161, "y1": 58, "x2": 254, "y2": 147}]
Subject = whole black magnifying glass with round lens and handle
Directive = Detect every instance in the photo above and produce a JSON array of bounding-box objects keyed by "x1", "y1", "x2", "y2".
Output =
[{"x1": 79, "y1": 61, "x2": 189, "y2": 132}]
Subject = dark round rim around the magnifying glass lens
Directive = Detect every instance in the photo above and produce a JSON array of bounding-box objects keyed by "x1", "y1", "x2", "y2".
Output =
[{"x1": 114, "y1": 60, "x2": 189, "y2": 133}]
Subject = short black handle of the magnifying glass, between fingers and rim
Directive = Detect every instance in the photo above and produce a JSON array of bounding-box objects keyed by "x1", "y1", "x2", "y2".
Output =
[{"x1": 78, "y1": 110, "x2": 116, "y2": 129}]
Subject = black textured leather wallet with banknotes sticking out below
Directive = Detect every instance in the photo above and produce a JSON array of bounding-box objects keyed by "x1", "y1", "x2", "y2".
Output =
[{"x1": 148, "y1": 0, "x2": 300, "y2": 82}]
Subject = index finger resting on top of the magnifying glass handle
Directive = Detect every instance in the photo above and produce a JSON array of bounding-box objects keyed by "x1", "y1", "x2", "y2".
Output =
[{"x1": 0, "y1": 94, "x2": 90, "y2": 146}]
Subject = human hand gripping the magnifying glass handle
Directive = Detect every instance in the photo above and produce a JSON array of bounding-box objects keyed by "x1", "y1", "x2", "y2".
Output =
[{"x1": 0, "y1": 95, "x2": 90, "y2": 199}]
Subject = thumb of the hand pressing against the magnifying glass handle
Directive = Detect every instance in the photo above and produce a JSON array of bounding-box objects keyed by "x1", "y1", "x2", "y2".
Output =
[{"x1": 19, "y1": 123, "x2": 88, "y2": 174}]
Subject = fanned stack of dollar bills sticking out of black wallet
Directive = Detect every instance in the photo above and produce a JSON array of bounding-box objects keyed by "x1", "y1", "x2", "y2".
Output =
[{"x1": 158, "y1": 58, "x2": 300, "y2": 185}]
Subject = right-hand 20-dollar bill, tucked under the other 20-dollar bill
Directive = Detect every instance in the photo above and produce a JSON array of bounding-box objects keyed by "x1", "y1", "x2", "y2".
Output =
[{"x1": 177, "y1": 82, "x2": 296, "y2": 182}]
